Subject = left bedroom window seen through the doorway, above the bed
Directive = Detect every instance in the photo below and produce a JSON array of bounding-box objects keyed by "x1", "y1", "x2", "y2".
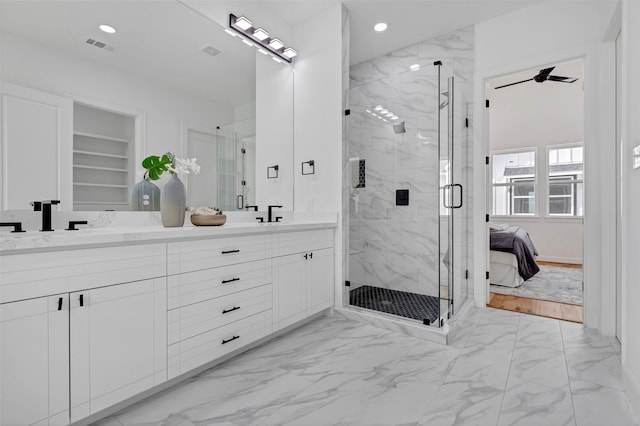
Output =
[{"x1": 491, "y1": 150, "x2": 536, "y2": 216}]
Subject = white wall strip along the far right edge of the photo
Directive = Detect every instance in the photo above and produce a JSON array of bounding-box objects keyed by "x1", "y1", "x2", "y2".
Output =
[{"x1": 622, "y1": 1, "x2": 640, "y2": 416}]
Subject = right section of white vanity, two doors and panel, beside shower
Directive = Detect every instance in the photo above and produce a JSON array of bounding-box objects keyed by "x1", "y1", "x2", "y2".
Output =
[{"x1": 273, "y1": 230, "x2": 334, "y2": 330}]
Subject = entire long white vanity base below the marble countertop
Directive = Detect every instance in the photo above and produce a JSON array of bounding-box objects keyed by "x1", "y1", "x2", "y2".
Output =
[{"x1": 0, "y1": 225, "x2": 334, "y2": 426}]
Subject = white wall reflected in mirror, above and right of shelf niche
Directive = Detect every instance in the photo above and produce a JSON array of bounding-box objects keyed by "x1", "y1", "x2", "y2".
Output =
[{"x1": 2, "y1": 34, "x2": 234, "y2": 190}]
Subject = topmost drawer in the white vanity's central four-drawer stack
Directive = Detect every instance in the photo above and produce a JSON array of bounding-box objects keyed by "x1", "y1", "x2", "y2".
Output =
[{"x1": 167, "y1": 235, "x2": 271, "y2": 275}]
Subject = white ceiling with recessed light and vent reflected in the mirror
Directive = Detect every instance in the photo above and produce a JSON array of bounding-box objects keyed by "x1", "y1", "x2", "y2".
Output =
[{"x1": 0, "y1": 0, "x2": 256, "y2": 106}]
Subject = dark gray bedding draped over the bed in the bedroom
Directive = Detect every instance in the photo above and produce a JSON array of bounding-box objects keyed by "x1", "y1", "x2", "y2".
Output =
[{"x1": 489, "y1": 226, "x2": 540, "y2": 280}]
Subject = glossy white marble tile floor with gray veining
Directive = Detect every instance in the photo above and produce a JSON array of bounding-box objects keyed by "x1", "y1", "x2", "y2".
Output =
[{"x1": 98, "y1": 308, "x2": 638, "y2": 426}]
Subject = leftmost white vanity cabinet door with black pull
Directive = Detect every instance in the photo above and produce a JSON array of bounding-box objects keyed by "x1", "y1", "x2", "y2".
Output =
[{"x1": 0, "y1": 294, "x2": 69, "y2": 425}]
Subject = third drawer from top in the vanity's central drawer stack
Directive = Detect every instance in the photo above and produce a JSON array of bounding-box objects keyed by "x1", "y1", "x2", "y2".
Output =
[{"x1": 168, "y1": 284, "x2": 272, "y2": 344}]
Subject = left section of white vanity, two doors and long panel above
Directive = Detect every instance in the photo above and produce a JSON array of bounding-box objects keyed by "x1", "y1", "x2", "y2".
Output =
[{"x1": 0, "y1": 244, "x2": 166, "y2": 425}]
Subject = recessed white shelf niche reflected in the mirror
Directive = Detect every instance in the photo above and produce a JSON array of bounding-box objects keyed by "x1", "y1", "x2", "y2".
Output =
[{"x1": 73, "y1": 103, "x2": 135, "y2": 211}]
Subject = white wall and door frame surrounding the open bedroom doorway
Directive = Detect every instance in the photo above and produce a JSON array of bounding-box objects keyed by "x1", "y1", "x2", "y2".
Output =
[{"x1": 474, "y1": 1, "x2": 615, "y2": 335}]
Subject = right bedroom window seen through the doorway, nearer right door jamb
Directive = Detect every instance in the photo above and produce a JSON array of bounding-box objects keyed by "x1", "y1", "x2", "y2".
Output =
[{"x1": 549, "y1": 145, "x2": 584, "y2": 216}]
